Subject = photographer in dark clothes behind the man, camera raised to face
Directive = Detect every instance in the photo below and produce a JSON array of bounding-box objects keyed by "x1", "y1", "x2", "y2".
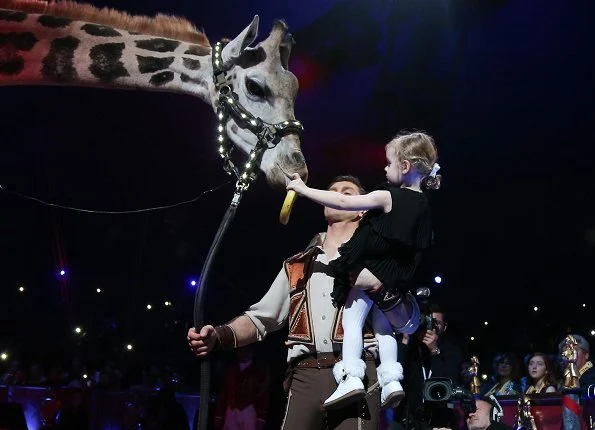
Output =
[{"x1": 389, "y1": 303, "x2": 462, "y2": 430}]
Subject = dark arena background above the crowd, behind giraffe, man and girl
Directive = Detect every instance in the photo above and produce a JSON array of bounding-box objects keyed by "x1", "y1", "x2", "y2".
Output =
[{"x1": 0, "y1": 0, "x2": 595, "y2": 386}]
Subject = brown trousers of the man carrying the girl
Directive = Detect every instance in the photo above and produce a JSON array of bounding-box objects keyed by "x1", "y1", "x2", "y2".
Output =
[{"x1": 282, "y1": 360, "x2": 380, "y2": 430}]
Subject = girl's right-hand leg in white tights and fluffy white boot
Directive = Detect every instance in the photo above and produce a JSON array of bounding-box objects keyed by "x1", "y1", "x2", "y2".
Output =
[{"x1": 372, "y1": 306, "x2": 405, "y2": 408}]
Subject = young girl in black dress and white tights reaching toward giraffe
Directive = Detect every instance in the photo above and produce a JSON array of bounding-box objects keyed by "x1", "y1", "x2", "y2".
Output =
[{"x1": 287, "y1": 132, "x2": 440, "y2": 409}]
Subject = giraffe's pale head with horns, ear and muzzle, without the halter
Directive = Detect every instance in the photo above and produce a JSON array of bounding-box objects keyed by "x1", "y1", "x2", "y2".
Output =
[{"x1": 211, "y1": 16, "x2": 308, "y2": 190}]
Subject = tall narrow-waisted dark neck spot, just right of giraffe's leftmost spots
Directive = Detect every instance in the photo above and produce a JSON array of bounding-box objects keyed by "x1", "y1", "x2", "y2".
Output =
[{"x1": 41, "y1": 36, "x2": 80, "y2": 82}]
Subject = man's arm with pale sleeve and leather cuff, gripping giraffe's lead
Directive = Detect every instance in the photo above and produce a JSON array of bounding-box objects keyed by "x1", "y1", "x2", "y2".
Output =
[{"x1": 187, "y1": 269, "x2": 289, "y2": 357}]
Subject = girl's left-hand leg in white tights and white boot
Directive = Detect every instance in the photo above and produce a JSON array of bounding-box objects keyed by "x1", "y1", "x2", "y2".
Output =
[{"x1": 324, "y1": 288, "x2": 373, "y2": 409}]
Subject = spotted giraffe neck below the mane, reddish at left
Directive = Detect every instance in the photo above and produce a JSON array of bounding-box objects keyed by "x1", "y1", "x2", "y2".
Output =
[{"x1": 0, "y1": 9, "x2": 213, "y2": 104}]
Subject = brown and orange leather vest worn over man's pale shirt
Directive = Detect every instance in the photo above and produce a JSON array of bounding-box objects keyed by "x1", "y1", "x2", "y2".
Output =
[{"x1": 284, "y1": 242, "x2": 374, "y2": 346}]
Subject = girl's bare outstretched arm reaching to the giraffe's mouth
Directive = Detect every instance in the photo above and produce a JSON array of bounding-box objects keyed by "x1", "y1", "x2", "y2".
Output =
[{"x1": 287, "y1": 173, "x2": 392, "y2": 212}]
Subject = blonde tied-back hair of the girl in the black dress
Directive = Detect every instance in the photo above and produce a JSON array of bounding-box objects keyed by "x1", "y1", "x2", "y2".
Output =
[{"x1": 386, "y1": 131, "x2": 442, "y2": 190}]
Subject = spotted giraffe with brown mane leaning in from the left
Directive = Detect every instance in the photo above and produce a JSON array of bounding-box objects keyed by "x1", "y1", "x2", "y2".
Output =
[{"x1": 0, "y1": 0, "x2": 308, "y2": 190}]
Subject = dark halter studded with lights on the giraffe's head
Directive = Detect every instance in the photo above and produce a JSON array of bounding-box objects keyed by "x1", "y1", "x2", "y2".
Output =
[{"x1": 212, "y1": 41, "x2": 304, "y2": 191}]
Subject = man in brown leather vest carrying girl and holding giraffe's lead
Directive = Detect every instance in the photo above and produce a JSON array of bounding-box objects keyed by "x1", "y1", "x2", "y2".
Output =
[{"x1": 188, "y1": 176, "x2": 420, "y2": 430}]
